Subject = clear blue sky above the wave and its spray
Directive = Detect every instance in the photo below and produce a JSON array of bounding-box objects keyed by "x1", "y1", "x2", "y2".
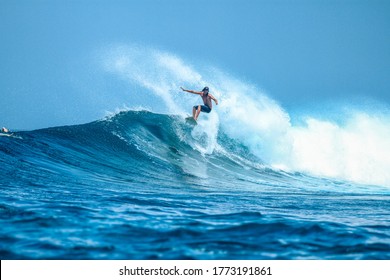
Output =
[{"x1": 0, "y1": 0, "x2": 390, "y2": 129}]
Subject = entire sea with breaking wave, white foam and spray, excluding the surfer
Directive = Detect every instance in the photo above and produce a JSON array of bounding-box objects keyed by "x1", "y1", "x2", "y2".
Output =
[{"x1": 0, "y1": 45, "x2": 390, "y2": 259}]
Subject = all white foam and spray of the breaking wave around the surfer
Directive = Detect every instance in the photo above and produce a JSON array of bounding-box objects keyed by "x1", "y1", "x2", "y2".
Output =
[{"x1": 104, "y1": 46, "x2": 390, "y2": 186}]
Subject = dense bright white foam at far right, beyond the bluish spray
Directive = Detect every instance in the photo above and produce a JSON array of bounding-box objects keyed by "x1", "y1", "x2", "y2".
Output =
[{"x1": 290, "y1": 113, "x2": 390, "y2": 186}]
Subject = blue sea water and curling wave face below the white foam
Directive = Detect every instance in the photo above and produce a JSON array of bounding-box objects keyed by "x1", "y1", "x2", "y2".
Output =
[{"x1": 0, "y1": 111, "x2": 390, "y2": 259}]
